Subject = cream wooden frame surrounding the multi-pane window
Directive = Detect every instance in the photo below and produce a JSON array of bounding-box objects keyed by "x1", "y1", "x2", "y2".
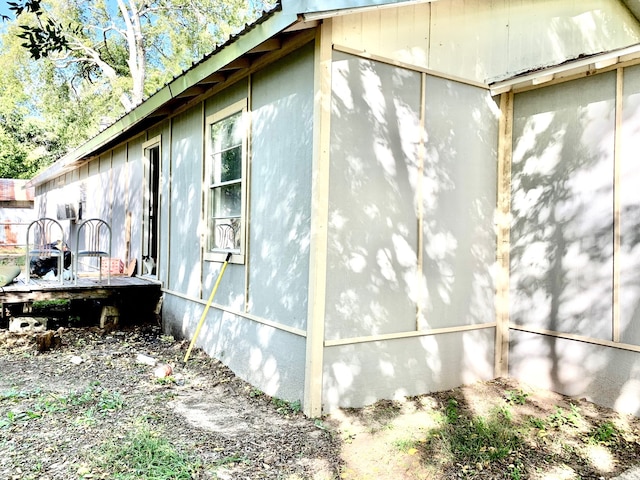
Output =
[{"x1": 203, "y1": 98, "x2": 249, "y2": 263}]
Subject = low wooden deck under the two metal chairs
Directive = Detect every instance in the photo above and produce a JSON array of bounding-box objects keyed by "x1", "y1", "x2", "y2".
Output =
[{"x1": 0, "y1": 276, "x2": 161, "y2": 304}]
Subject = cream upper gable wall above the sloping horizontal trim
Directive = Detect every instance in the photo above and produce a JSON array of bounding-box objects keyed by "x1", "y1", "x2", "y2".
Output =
[{"x1": 333, "y1": 0, "x2": 640, "y2": 82}]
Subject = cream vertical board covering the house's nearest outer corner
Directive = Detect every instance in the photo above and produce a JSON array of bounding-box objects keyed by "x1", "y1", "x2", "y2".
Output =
[{"x1": 304, "y1": 20, "x2": 332, "y2": 417}]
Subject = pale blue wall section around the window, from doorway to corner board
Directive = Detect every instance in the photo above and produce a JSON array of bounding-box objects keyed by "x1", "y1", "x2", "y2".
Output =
[{"x1": 163, "y1": 45, "x2": 314, "y2": 401}]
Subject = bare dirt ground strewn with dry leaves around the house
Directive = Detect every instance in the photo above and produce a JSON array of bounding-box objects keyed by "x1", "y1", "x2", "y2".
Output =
[{"x1": 0, "y1": 325, "x2": 640, "y2": 480}]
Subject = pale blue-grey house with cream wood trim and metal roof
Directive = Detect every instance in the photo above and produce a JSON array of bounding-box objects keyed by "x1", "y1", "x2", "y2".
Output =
[{"x1": 31, "y1": 0, "x2": 640, "y2": 416}]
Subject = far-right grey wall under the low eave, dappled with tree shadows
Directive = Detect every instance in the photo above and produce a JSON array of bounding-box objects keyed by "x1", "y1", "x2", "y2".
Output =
[{"x1": 509, "y1": 66, "x2": 640, "y2": 415}]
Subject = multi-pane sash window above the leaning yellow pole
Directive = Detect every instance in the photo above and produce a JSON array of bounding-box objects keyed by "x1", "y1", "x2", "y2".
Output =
[{"x1": 205, "y1": 101, "x2": 247, "y2": 261}]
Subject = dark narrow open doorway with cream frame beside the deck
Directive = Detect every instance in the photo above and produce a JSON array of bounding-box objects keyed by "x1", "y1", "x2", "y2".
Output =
[{"x1": 139, "y1": 137, "x2": 160, "y2": 276}]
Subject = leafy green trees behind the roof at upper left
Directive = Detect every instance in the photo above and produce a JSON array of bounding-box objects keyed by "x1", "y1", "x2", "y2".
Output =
[{"x1": 0, "y1": 0, "x2": 273, "y2": 178}]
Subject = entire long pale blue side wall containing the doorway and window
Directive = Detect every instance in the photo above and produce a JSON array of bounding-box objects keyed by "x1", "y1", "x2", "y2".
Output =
[{"x1": 36, "y1": 45, "x2": 314, "y2": 401}]
